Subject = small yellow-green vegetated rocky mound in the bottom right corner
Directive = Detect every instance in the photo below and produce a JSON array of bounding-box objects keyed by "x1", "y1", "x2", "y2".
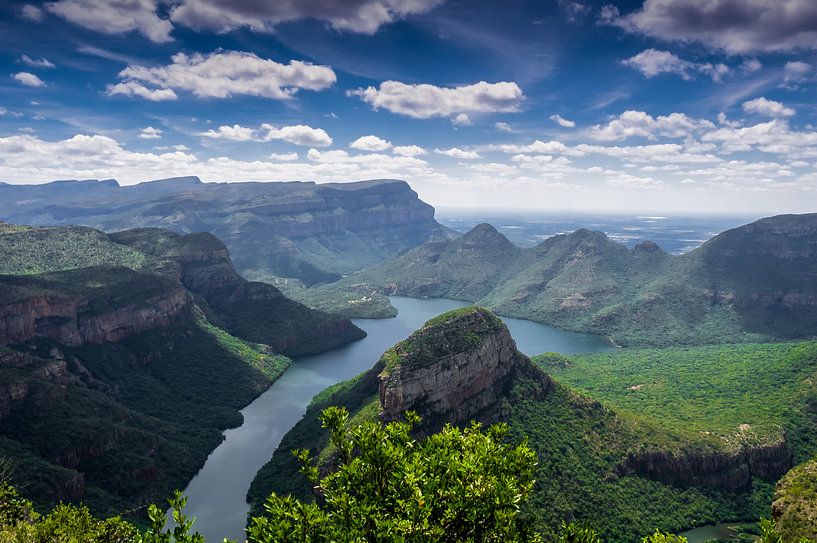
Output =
[{"x1": 772, "y1": 460, "x2": 817, "y2": 541}]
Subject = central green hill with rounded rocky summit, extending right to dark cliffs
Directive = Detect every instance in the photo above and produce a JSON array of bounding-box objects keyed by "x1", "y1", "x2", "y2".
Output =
[{"x1": 248, "y1": 307, "x2": 791, "y2": 541}]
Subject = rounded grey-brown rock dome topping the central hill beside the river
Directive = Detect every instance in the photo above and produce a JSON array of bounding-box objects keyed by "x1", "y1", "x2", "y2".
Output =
[{"x1": 379, "y1": 308, "x2": 549, "y2": 422}]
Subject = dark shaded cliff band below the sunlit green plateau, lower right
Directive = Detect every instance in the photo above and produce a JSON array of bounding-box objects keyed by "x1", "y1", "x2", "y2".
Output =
[{"x1": 620, "y1": 434, "x2": 792, "y2": 490}]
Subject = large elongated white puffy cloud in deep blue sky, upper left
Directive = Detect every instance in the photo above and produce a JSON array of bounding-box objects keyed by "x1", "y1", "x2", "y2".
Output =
[{"x1": 108, "y1": 51, "x2": 337, "y2": 100}]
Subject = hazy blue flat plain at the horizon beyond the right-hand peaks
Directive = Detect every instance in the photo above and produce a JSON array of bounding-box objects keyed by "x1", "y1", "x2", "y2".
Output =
[{"x1": 437, "y1": 208, "x2": 760, "y2": 254}]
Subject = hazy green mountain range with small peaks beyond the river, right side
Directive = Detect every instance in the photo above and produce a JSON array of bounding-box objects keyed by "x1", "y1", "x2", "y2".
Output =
[{"x1": 333, "y1": 214, "x2": 817, "y2": 346}]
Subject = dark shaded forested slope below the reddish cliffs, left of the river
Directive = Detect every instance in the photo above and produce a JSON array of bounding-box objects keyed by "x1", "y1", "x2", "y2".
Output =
[{"x1": 0, "y1": 306, "x2": 289, "y2": 514}]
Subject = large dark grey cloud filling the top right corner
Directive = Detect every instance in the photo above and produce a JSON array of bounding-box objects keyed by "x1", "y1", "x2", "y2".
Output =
[{"x1": 600, "y1": 0, "x2": 817, "y2": 54}]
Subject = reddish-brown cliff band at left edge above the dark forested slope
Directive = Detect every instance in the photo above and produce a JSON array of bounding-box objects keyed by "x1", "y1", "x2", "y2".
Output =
[{"x1": 0, "y1": 287, "x2": 191, "y2": 346}]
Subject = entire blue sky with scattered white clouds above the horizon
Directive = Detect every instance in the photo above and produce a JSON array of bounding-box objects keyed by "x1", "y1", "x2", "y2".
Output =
[{"x1": 0, "y1": 0, "x2": 817, "y2": 214}]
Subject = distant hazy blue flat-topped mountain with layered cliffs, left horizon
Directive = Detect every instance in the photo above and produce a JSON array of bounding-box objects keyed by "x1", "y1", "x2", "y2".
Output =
[{"x1": 0, "y1": 177, "x2": 450, "y2": 284}]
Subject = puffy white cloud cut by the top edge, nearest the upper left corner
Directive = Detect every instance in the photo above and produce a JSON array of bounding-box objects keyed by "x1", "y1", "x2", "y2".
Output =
[{"x1": 45, "y1": 0, "x2": 173, "y2": 43}]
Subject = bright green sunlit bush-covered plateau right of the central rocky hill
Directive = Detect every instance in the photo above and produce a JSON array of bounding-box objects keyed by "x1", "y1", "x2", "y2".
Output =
[{"x1": 534, "y1": 342, "x2": 817, "y2": 461}]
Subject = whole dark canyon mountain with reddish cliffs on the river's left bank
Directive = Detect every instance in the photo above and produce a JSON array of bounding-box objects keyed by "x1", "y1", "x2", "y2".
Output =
[{"x1": 0, "y1": 224, "x2": 364, "y2": 514}]
